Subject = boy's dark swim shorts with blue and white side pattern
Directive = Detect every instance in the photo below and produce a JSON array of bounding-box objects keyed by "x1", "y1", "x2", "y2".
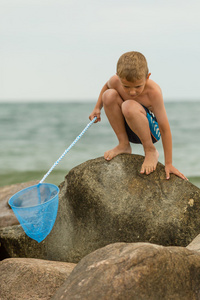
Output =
[{"x1": 124, "y1": 105, "x2": 160, "y2": 144}]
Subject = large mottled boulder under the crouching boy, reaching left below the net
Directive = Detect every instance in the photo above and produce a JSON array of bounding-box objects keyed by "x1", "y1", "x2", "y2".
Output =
[{"x1": 0, "y1": 154, "x2": 200, "y2": 262}]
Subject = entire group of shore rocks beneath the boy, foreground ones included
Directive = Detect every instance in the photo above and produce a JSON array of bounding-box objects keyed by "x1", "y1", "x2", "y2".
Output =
[{"x1": 0, "y1": 154, "x2": 200, "y2": 300}]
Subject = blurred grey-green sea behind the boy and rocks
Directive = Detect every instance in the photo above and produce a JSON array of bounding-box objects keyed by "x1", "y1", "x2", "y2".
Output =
[{"x1": 0, "y1": 100, "x2": 200, "y2": 187}]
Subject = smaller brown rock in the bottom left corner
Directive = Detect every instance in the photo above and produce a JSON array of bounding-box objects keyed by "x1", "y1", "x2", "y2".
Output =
[{"x1": 0, "y1": 258, "x2": 75, "y2": 300}]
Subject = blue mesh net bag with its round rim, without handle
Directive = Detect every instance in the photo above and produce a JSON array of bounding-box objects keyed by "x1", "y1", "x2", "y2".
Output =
[{"x1": 8, "y1": 183, "x2": 59, "y2": 243}]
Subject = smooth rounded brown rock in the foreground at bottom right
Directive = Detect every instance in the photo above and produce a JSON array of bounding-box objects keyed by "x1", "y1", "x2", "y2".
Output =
[{"x1": 52, "y1": 243, "x2": 200, "y2": 300}]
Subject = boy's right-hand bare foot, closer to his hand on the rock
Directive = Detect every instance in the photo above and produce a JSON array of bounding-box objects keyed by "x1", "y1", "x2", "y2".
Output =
[{"x1": 140, "y1": 149, "x2": 159, "y2": 175}]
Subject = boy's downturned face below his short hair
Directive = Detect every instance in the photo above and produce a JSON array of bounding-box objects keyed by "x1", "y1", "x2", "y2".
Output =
[{"x1": 119, "y1": 77, "x2": 148, "y2": 98}]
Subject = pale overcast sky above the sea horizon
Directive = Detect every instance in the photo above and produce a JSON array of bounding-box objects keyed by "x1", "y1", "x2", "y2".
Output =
[{"x1": 0, "y1": 0, "x2": 200, "y2": 102}]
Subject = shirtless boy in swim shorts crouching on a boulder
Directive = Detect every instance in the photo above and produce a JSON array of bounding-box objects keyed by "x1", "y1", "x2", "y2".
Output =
[{"x1": 89, "y1": 51, "x2": 187, "y2": 179}]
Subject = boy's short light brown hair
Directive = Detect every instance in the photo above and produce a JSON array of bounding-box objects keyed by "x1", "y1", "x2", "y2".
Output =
[{"x1": 117, "y1": 51, "x2": 149, "y2": 82}]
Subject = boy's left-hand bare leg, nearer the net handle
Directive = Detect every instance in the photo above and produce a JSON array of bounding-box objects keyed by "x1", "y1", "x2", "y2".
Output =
[{"x1": 102, "y1": 89, "x2": 131, "y2": 160}]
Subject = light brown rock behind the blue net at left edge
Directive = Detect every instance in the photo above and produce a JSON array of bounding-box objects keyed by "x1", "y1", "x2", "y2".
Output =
[{"x1": 0, "y1": 180, "x2": 38, "y2": 228}]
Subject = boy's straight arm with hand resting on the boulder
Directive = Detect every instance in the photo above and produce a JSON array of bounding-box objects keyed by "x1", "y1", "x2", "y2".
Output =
[{"x1": 153, "y1": 93, "x2": 187, "y2": 179}]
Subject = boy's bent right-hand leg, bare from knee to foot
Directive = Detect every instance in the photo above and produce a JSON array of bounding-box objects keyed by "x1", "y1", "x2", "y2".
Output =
[{"x1": 122, "y1": 100, "x2": 159, "y2": 174}]
